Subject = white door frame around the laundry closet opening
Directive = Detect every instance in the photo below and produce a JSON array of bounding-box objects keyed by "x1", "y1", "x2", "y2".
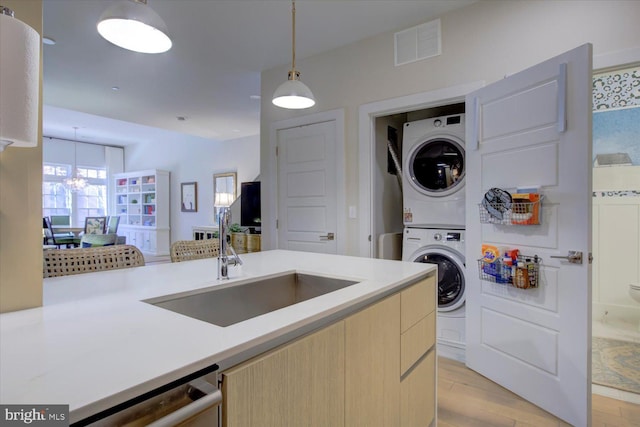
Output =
[{"x1": 358, "y1": 81, "x2": 485, "y2": 258}]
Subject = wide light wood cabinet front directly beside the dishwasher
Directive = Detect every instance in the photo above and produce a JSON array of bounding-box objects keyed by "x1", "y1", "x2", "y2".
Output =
[{"x1": 222, "y1": 322, "x2": 344, "y2": 427}]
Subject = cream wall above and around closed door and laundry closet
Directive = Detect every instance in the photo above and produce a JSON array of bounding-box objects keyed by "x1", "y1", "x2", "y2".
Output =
[{"x1": 260, "y1": 0, "x2": 640, "y2": 255}]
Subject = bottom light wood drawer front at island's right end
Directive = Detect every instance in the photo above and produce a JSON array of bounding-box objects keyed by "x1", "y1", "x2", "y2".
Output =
[{"x1": 400, "y1": 349, "x2": 436, "y2": 427}]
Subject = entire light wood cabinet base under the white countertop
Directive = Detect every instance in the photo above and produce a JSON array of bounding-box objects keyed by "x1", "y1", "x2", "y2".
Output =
[{"x1": 222, "y1": 274, "x2": 436, "y2": 427}]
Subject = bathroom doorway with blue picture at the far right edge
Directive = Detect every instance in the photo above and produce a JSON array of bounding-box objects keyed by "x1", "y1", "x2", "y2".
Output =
[{"x1": 592, "y1": 65, "x2": 640, "y2": 403}]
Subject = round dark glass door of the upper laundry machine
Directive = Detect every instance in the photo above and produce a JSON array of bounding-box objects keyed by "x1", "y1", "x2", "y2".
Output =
[{"x1": 405, "y1": 136, "x2": 465, "y2": 197}]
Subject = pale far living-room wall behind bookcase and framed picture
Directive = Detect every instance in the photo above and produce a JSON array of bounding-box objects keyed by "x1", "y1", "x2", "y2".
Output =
[{"x1": 124, "y1": 135, "x2": 260, "y2": 242}]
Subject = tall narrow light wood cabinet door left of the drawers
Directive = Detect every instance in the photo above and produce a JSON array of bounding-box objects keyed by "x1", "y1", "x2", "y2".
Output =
[{"x1": 345, "y1": 294, "x2": 400, "y2": 427}]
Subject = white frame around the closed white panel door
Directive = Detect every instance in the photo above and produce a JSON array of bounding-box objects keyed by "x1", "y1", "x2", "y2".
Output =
[{"x1": 263, "y1": 108, "x2": 347, "y2": 255}]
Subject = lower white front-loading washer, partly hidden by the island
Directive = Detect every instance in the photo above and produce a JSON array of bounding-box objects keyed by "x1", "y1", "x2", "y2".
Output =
[{"x1": 402, "y1": 228, "x2": 466, "y2": 362}]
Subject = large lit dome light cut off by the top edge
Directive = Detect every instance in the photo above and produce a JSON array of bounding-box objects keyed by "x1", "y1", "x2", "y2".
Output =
[{"x1": 97, "y1": 0, "x2": 172, "y2": 53}]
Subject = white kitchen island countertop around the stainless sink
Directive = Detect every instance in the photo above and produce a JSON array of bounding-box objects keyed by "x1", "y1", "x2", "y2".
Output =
[{"x1": 0, "y1": 250, "x2": 435, "y2": 422}]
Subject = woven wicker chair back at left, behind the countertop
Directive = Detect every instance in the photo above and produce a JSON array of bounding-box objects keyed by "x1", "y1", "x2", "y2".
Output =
[{"x1": 42, "y1": 245, "x2": 144, "y2": 277}]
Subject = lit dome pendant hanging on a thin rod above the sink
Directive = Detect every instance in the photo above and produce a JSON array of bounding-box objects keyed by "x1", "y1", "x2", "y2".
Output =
[{"x1": 272, "y1": 0, "x2": 316, "y2": 110}]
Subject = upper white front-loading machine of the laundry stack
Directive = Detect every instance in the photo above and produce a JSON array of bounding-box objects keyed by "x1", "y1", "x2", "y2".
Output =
[{"x1": 402, "y1": 114, "x2": 465, "y2": 229}]
